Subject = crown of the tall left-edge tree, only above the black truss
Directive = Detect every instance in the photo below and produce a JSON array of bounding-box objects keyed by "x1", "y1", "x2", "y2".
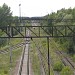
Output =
[{"x1": 0, "y1": 3, "x2": 12, "y2": 26}]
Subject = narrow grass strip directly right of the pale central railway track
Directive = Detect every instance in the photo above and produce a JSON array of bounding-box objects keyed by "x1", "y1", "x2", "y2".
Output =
[{"x1": 30, "y1": 40, "x2": 40, "y2": 75}]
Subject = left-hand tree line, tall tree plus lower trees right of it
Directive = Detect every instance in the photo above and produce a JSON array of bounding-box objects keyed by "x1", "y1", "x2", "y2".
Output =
[{"x1": 0, "y1": 3, "x2": 19, "y2": 47}]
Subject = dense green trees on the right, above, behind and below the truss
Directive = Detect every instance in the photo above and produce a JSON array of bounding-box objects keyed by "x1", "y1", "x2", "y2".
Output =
[{"x1": 42, "y1": 8, "x2": 75, "y2": 54}]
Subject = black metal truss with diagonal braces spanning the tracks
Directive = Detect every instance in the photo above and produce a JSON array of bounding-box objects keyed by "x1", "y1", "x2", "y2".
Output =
[{"x1": 0, "y1": 25, "x2": 75, "y2": 38}]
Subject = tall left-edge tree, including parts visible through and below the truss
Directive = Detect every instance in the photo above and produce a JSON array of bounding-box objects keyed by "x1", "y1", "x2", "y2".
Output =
[{"x1": 0, "y1": 3, "x2": 12, "y2": 46}]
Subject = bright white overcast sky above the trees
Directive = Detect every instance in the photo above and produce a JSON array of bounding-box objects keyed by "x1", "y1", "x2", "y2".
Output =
[{"x1": 0, "y1": 0, "x2": 75, "y2": 17}]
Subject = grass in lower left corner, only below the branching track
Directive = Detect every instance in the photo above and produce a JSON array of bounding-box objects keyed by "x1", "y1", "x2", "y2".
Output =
[{"x1": 0, "y1": 48, "x2": 22, "y2": 75}]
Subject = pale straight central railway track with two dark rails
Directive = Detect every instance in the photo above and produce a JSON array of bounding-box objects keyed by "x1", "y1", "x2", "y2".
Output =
[{"x1": 16, "y1": 32, "x2": 33, "y2": 75}]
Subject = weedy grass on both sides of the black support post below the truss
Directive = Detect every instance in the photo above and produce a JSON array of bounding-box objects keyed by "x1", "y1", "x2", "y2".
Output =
[{"x1": 30, "y1": 38, "x2": 67, "y2": 75}]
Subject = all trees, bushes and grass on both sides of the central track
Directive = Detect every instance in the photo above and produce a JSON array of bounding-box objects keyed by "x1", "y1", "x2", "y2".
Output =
[{"x1": 0, "y1": 3, "x2": 75, "y2": 75}]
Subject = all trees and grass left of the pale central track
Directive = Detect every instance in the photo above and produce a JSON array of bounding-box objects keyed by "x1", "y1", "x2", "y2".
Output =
[{"x1": 0, "y1": 3, "x2": 23, "y2": 75}]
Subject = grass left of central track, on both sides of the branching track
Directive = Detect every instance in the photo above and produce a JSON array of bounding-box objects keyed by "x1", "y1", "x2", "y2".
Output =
[{"x1": 0, "y1": 36, "x2": 23, "y2": 75}]
